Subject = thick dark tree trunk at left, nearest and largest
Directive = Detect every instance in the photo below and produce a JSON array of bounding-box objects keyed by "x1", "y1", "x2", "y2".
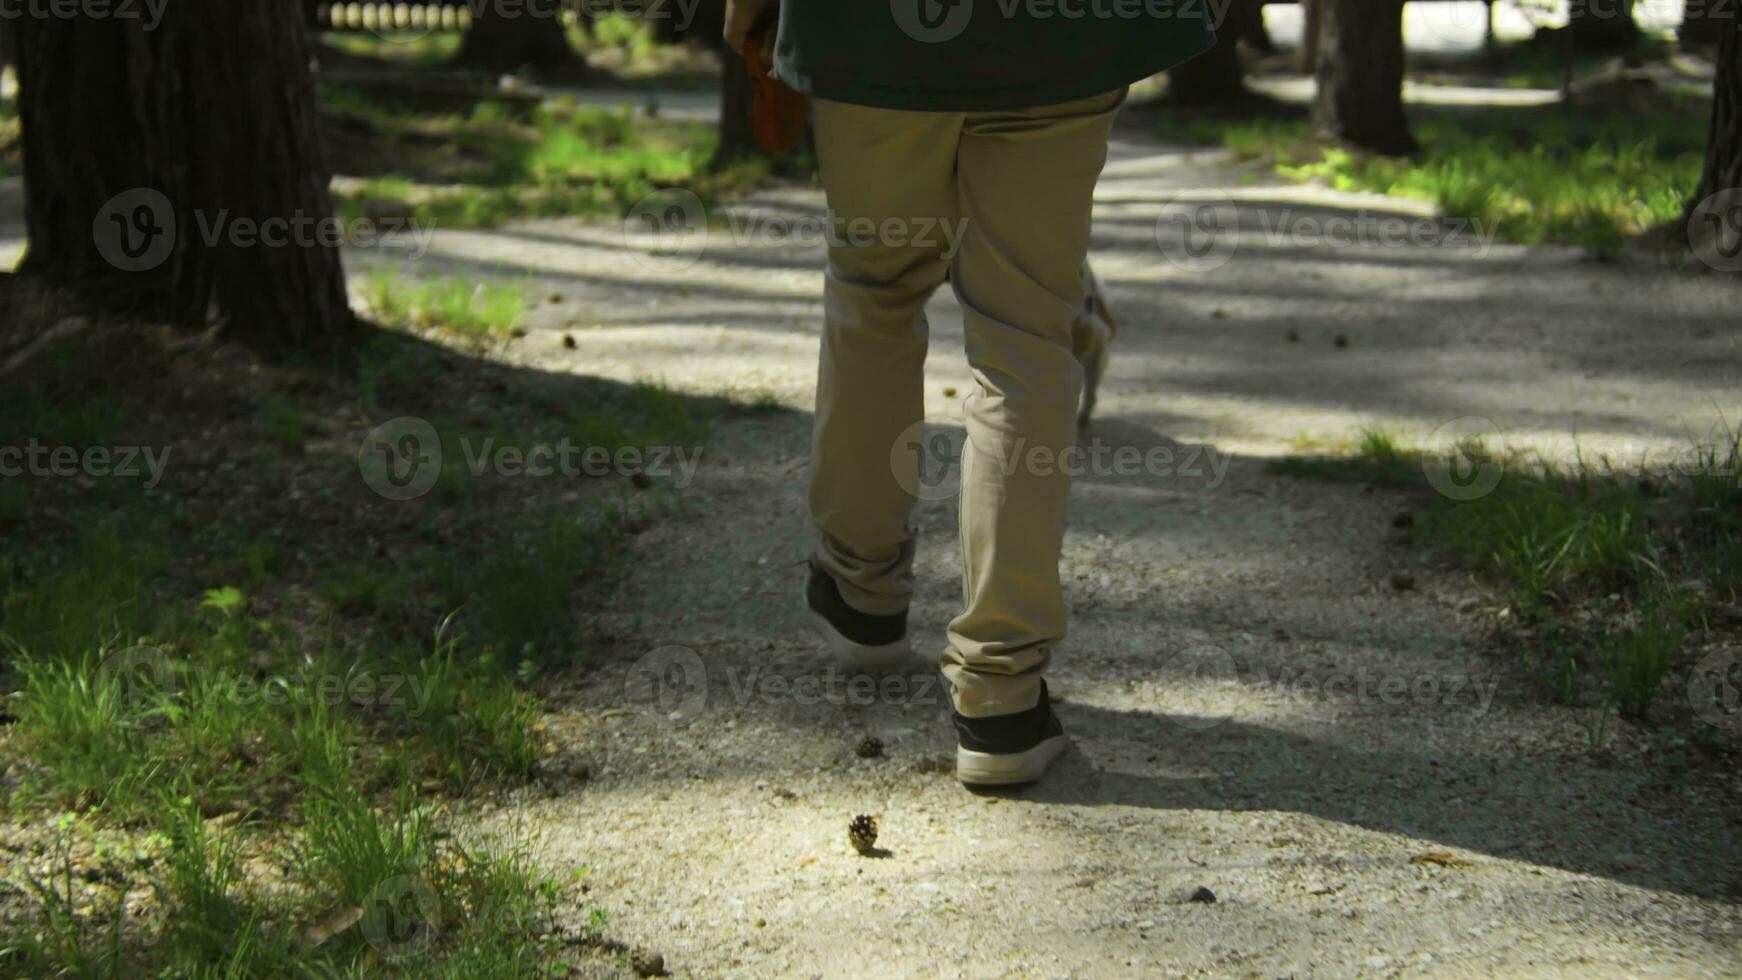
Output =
[{"x1": 12, "y1": 0, "x2": 354, "y2": 352}]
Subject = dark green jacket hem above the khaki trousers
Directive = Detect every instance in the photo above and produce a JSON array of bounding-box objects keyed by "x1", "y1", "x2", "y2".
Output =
[{"x1": 775, "y1": 0, "x2": 1219, "y2": 111}]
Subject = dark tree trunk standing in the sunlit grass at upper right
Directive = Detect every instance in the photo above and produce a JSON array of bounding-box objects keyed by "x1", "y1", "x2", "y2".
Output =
[{"x1": 1312, "y1": 0, "x2": 1416, "y2": 153}]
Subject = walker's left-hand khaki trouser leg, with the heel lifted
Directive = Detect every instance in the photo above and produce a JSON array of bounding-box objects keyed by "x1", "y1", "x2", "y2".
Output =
[{"x1": 810, "y1": 99, "x2": 963, "y2": 616}]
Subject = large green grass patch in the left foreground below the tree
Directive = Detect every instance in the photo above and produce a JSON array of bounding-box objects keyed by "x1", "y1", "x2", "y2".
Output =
[{"x1": 0, "y1": 323, "x2": 707, "y2": 977}]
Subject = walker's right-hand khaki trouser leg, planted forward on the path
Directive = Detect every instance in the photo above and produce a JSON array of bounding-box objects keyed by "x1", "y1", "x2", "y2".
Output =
[{"x1": 942, "y1": 92, "x2": 1124, "y2": 719}]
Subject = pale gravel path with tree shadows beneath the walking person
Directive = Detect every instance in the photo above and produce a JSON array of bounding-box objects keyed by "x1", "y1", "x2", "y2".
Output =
[{"x1": 359, "y1": 119, "x2": 1742, "y2": 977}]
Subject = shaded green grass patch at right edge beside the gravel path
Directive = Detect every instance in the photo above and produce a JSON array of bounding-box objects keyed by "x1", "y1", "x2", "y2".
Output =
[{"x1": 1270, "y1": 432, "x2": 1742, "y2": 719}]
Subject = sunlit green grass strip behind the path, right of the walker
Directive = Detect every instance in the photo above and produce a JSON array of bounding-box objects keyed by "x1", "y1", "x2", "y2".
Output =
[{"x1": 1164, "y1": 104, "x2": 1705, "y2": 256}]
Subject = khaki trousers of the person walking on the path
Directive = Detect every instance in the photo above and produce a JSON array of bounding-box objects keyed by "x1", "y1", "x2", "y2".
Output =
[{"x1": 810, "y1": 91, "x2": 1125, "y2": 717}]
